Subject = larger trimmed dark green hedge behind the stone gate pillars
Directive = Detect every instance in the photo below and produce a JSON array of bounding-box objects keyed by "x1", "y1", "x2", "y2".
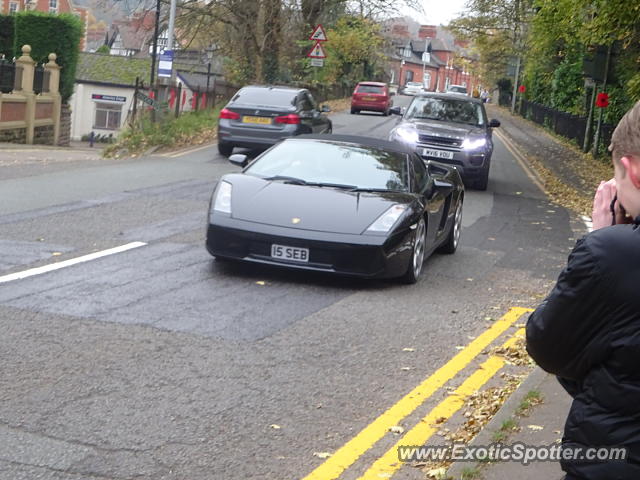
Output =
[{"x1": 14, "y1": 12, "x2": 84, "y2": 102}]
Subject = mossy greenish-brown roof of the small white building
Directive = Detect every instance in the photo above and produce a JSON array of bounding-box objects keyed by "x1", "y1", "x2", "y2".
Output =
[{"x1": 76, "y1": 52, "x2": 151, "y2": 87}]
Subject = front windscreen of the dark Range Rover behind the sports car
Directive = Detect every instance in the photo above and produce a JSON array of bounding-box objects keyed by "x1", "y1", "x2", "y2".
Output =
[{"x1": 405, "y1": 97, "x2": 485, "y2": 126}]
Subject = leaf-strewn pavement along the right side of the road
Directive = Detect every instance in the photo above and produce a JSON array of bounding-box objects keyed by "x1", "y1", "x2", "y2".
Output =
[{"x1": 447, "y1": 105, "x2": 587, "y2": 480}]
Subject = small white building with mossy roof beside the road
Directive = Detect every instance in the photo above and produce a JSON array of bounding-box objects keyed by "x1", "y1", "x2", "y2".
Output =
[{"x1": 69, "y1": 52, "x2": 151, "y2": 140}]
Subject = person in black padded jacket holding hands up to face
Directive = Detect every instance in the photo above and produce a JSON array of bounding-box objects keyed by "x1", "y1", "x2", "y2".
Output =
[{"x1": 527, "y1": 98, "x2": 640, "y2": 480}]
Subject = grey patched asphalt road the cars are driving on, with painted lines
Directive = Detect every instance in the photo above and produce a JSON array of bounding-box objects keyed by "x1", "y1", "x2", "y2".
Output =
[{"x1": 0, "y1": 97, "x2": 574, "y2": 480}]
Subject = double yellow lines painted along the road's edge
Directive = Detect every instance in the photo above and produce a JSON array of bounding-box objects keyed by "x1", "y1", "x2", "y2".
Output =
[{"x1": 303, "y1": 307, "x2": 531, "y2": 480}]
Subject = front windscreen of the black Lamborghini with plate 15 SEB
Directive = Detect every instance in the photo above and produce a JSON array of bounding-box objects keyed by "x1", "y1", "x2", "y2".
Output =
[{"x1": 245, "y1": 139, "x2": 408, "y2": 191}]
